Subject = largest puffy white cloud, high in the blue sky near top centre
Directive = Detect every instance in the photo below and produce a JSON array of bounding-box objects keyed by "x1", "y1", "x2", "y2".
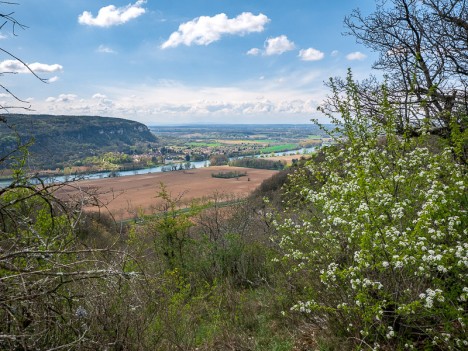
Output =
[{"x1": 161, "y1": 12, "x2": 270, "y2": 49}]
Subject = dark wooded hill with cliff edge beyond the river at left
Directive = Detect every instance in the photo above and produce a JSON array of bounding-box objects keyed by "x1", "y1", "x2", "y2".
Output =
[{"x1": 0, "y1": 114, "x2": 157, "y2": 168}]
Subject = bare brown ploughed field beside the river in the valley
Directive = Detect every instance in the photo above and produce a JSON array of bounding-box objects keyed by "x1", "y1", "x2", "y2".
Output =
[{"x1": 56, "y1": 166, "x2": 277, "y2": 219}]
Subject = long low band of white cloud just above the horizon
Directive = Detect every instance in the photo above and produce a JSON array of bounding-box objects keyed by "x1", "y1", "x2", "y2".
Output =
[{"x1": 34, "y1": 80, "x2": 323, "y2": 124}]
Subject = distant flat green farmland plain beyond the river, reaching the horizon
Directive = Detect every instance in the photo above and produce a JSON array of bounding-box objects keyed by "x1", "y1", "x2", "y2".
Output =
[{"x1": 149, "y1": 124, "x2": 328, "y2": 162}]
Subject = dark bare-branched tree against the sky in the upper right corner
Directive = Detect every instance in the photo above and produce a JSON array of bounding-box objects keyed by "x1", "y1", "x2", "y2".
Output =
[{"x1": 329, "y1": 0, "x2": 468, "y2": 138}]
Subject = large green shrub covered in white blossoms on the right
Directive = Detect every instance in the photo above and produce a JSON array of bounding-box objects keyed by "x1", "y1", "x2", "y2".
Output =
[{"x1": 274, "y1": 77, "x2": 468, "y2": 349}]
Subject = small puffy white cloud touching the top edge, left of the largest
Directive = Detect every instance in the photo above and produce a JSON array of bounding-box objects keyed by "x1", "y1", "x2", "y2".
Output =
[{"x1": 78, "y1": 0, "x2": 146, "y2": 27}]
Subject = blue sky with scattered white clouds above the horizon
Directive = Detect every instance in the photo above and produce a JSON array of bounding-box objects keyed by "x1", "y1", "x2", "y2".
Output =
[{"x1": 0, "y1": 0, "x2": 376, "y2": 125}]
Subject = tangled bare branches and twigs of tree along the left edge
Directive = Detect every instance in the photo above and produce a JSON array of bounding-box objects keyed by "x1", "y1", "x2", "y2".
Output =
[{"x1": 0, "y1": 1, "x2": 138, "y2": 350}]
